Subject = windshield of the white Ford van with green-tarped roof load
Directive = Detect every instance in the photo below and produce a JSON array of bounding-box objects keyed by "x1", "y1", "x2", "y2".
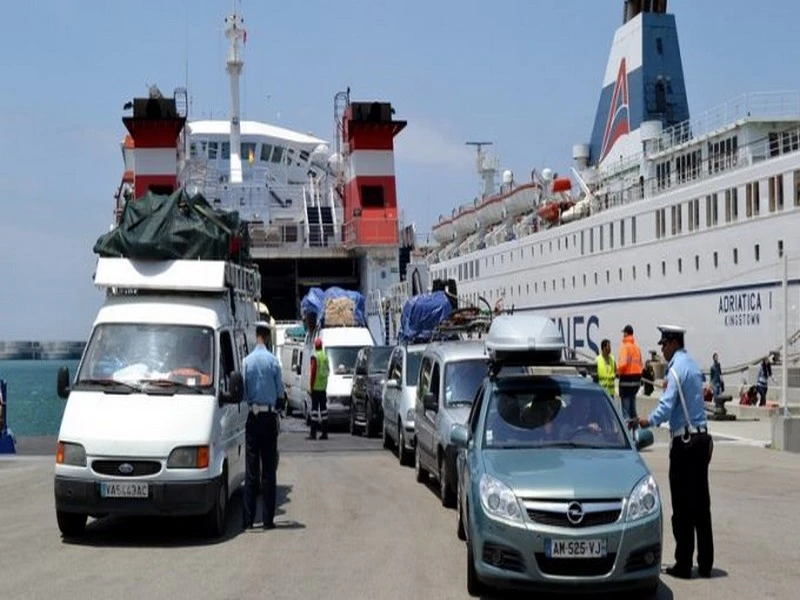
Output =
[{"x1": 75, "y1": 323, "x2": 214, "y2": 392}]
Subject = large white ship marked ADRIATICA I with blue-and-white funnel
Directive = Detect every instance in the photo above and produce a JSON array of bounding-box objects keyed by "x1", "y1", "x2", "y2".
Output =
[{"x1": 382, "y1": 0, "x2": 800, "y2": 376}]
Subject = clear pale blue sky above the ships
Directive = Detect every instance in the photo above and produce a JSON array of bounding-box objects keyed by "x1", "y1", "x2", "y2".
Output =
[{"x1": 0, "y1": 0, "x2": 800, "y2": 340}]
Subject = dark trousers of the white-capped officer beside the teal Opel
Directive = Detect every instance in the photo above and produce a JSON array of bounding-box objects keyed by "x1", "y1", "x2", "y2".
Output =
[{"x1": 669, "y1": 433, "x2": 714, "y2": 573}]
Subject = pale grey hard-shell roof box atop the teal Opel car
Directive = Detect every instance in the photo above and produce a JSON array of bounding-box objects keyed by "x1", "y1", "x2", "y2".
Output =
[{"x1": 485, "y1": 315, "x2": 566, "y2": 366}]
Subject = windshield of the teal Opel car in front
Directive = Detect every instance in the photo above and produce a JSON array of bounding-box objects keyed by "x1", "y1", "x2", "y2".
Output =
[{"x1": 483, "y1": 377, "x2": 630, "y2": 449}]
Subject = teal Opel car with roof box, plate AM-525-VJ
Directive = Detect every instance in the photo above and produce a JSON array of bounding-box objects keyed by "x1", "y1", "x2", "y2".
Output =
[{"x1": 451, "y1": 316, "x2": 662, "y2": 596}]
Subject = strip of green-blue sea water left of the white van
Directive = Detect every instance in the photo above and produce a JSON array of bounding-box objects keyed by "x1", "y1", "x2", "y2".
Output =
[{"x1": 0, "y1": 360, "x2": 78, "y2": 437}]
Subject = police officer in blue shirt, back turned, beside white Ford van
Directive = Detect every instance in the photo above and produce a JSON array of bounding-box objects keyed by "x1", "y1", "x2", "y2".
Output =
[{"x1": 242, "y1": 322, "x2": 283, "y2": 529}]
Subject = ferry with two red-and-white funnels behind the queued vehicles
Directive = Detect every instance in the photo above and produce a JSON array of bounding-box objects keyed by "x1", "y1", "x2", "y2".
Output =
[{"x1": 115, "y1": 13, "x2": 406, "y2": 321}]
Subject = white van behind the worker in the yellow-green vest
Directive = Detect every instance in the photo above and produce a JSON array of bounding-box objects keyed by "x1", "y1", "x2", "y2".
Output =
[{"x1": 300, "y1": 327, "x2": 375, "y2": 424}]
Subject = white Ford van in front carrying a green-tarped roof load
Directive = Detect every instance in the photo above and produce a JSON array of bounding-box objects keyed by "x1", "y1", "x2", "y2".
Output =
[{"x1": 55, "y1": 258, "x2": 261, "y2": 536}]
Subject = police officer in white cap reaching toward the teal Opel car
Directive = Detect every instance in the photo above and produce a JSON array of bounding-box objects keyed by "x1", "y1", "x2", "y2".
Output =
[{"x1": 628, "y1": 325, "x2": 714, "y2": 579}]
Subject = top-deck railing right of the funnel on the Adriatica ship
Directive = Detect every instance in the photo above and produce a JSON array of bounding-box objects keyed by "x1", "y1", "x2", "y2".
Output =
[{"x1": 659, "y1": 91, "x2": 800, "y2": 151}]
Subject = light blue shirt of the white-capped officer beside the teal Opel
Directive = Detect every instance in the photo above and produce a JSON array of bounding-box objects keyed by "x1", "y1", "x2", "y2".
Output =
[{"x1": 649, "y1": 349, "x2": 707, "y2": 434}]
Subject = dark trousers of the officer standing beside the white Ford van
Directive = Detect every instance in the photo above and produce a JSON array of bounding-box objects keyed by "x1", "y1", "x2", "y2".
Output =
[{"x1": 242, "y1": 412, "x2": 278, "y2": 527}]
